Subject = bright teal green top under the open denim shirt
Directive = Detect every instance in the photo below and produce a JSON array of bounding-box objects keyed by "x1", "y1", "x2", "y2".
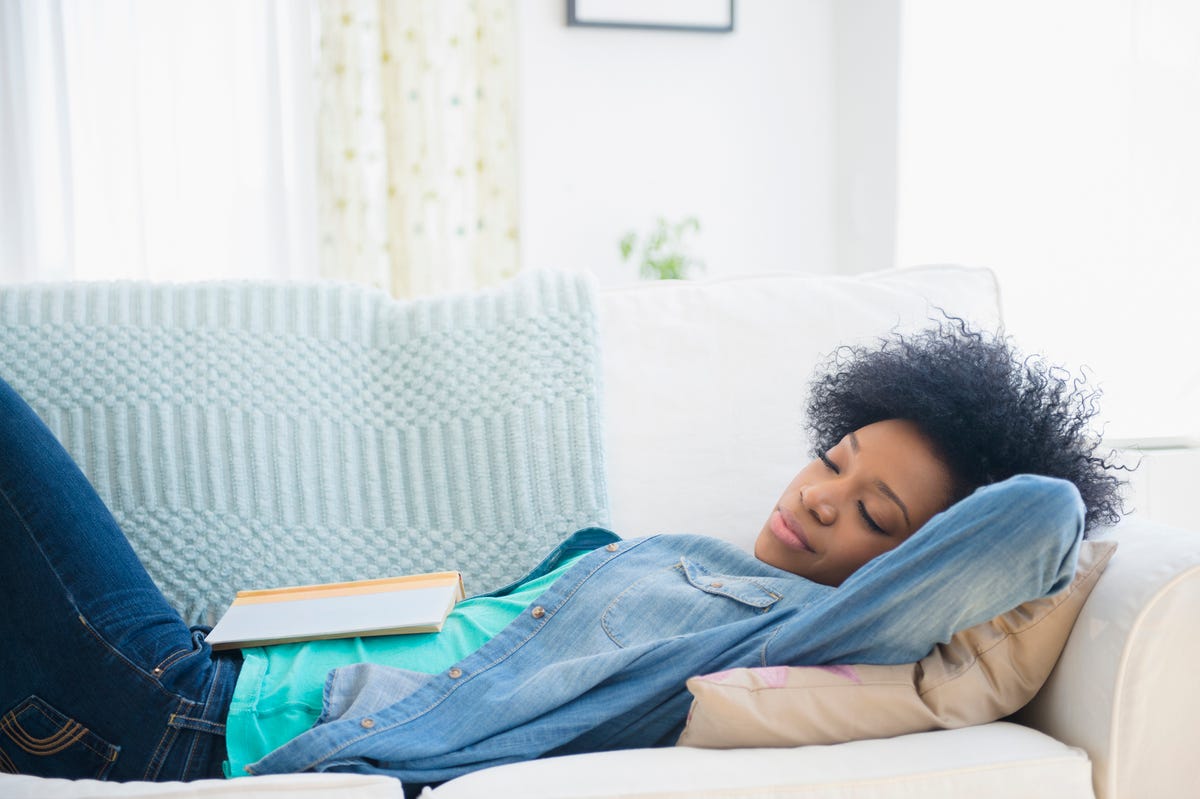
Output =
[{"x1": 224, "y1": 553, "x2": 586, "y2": 776}]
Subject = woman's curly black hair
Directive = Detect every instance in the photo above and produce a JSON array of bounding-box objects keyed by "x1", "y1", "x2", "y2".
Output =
[{"x1": 808, "y1": 317, "x2": 1123, "y2": 529}]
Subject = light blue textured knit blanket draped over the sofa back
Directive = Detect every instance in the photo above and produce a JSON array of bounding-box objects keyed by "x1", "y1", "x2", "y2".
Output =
[{"x1": 0, "y1": 272, "x2": 608, "y2": 624}]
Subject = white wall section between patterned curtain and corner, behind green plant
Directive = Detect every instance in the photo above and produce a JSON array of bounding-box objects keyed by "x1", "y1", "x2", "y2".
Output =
[{"x1": 517, "y1": 0, "x2": 836, "y2": 283}]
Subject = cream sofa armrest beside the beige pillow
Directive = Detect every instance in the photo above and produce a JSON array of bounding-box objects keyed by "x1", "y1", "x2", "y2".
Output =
[{"x1": 1015, "y1": 517, "x2": 1200, "y2": 799}]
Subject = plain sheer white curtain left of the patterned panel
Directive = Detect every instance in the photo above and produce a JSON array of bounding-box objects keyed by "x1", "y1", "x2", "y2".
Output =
[{"x1": 0, "y1": 0, "x2": 317, "y2": 281}]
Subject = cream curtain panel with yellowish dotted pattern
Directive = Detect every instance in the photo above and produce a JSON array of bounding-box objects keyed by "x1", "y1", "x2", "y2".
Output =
[{"x1": 317, "y1": 0, "x2": 518, "y2": 296}]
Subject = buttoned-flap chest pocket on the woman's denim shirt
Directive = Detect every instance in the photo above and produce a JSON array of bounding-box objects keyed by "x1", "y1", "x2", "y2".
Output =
[{"x1": 600, "y1": 558, "x2": 781, "y2": 647}]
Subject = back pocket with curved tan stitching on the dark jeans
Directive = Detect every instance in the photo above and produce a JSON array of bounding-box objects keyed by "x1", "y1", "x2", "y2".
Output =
[{"x1": 0, "y1": 696, "x2": 121, "y2": 780}]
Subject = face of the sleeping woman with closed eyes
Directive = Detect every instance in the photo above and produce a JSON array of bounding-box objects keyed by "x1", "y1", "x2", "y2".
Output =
[{"x1": 754, "y1": 419, "x2": 952, "y2": 585}]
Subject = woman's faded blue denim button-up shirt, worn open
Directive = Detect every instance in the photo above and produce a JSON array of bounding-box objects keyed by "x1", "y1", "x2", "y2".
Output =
[{"x1": 247, "y1": 475, "x2": 1084, "y2": 782}]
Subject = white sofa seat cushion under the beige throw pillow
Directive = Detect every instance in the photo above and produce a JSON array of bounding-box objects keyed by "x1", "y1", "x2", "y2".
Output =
[{"x1": 428, "y1": 722, "x2": 1093, "y2": 799}]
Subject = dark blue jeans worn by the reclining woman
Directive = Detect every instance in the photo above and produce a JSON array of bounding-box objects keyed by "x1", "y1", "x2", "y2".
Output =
[{"x1": 0, "y1": 380, "x2": 240, "y2": 780}]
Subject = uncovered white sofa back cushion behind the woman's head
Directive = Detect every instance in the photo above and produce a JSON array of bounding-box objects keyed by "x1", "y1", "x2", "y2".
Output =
[{"x1": 600, "y1": 266, "x2": 1001, "y2": 549}]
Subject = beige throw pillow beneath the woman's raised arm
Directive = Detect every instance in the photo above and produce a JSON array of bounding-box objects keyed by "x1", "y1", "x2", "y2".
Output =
[{"x1": 678, "y1": 541, "x2": 1117, "y2": 749}]
